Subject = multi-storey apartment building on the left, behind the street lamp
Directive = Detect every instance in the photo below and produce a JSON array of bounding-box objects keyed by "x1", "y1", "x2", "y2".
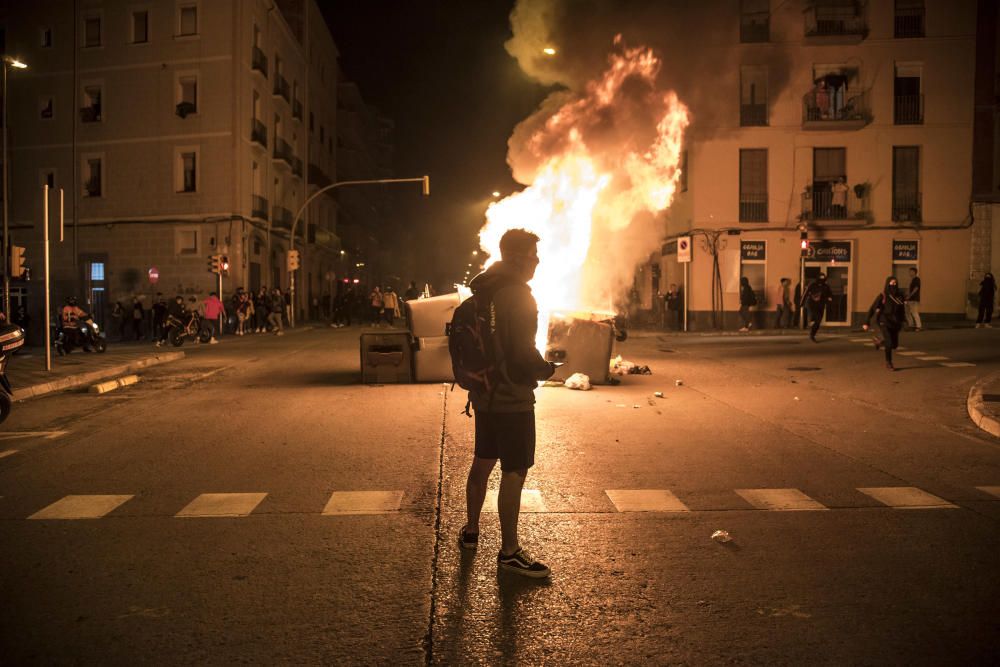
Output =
[{"x1": 0, "y1": 0, "x2": 386, "y2": 334}]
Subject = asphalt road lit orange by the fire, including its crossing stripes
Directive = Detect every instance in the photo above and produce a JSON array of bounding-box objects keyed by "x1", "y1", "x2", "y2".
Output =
[{"x1": 0, "y1": 328, "x2": 1000, "y2": 665}]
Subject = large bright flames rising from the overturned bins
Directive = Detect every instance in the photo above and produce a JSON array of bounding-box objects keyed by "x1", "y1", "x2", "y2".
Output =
[{"x1": 479, "y1": 37, "x2": 688, "y2": 351}]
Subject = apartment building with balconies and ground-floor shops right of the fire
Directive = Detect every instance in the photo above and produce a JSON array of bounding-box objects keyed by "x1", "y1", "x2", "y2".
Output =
[{"x1": 637, "y1": 0, "x2": 984, "y2": 329}]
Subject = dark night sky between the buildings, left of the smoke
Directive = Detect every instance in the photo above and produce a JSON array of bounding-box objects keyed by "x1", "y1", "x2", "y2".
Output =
[{"x1": 320, "y1": 0, "x2": 551, "y2": 284}]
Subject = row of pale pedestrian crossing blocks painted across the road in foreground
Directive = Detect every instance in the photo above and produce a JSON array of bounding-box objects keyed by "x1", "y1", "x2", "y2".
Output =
[{"x1": 0, "y1": 486, "x2": 1000, "y2": 521}]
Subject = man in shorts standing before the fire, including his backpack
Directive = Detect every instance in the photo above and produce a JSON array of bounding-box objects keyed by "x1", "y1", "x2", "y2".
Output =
[{"x1": 449, "y1": 229, "x2": 555, "y2": 578}]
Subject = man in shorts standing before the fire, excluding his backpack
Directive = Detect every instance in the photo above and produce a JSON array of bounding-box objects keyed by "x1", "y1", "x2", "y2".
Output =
[{"x1": 459, "y1": 229, "x2": 555, "y2": 578}]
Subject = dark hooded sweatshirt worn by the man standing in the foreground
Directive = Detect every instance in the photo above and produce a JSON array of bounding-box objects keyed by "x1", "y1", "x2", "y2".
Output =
[{"x1": 469, "y1": 261, "x2": 554, "y2": 412}]
